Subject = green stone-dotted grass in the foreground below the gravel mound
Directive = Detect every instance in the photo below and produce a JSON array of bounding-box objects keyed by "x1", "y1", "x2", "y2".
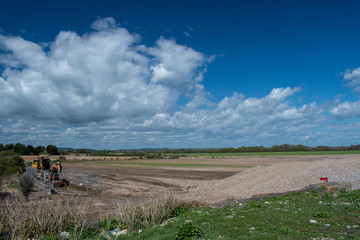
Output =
[{"x1": 117, "y1": 190, "x2": 360, "y2": 240}]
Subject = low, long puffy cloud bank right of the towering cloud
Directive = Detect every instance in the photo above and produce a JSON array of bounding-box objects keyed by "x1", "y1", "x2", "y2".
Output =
[{"x1": 144, "y1": 87, "x2": 322, "y2": 142}]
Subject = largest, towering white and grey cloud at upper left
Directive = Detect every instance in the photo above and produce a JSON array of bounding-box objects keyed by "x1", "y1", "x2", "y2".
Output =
[{"x1": 0, "y1": 18, "x2": 206, "y2": 123}]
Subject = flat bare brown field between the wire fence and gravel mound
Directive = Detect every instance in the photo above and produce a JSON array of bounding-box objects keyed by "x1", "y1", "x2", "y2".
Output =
[{"x1": 26, "y1": 155, "x2": 358, "y2": 219}]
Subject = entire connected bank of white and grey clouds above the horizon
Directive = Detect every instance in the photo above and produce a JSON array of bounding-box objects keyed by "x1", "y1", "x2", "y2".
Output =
[{"x1": 0, "y1": 18, "x2": 330, "y2": 149}]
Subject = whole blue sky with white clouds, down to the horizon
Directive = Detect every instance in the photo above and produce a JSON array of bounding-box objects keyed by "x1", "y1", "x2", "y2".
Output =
[{"x1": 0, "y1": 0, "x2": 360, "y2": 149}]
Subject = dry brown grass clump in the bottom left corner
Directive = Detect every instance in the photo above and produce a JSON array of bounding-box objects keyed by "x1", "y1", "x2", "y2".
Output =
[{"x1": 0, "y1": 198, "x2": 86, "y2": 239}]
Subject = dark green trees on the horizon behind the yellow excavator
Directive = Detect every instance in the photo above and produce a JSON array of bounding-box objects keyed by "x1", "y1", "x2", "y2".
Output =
[{"x1": 0, "y1": 143, "x2": 59, "y2": 155}]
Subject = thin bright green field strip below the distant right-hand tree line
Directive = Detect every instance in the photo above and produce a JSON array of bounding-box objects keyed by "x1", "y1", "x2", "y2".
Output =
[{"x1": 175, "y1": 150, "x2": 360, "y2": 157}]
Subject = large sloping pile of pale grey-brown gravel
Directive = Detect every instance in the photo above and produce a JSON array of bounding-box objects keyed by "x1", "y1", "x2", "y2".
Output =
[{"x1": 188, "y1": 157, "x2": 360, "y2": 204}]
